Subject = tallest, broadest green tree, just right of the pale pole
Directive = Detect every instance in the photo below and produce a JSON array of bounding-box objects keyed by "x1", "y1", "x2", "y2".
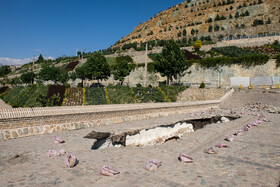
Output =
[{"x1": 155, "y1": 40, "x2": 190, "y2": 84}]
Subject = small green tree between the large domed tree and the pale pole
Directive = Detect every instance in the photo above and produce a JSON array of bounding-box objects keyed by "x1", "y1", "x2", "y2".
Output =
[{"x1": 112, "y1": 60, "x2": 132, "y2": 85}]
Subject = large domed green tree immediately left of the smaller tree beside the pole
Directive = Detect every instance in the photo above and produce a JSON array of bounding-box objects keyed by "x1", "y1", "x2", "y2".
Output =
[{"x1": 85, "y1": 52, "x2": 111, "y2": 82}]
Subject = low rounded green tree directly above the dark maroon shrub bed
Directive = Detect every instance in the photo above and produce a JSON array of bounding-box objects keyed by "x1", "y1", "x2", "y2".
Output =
[{"x1": 39, "y1": 65, "x2": 60, "y2": 84}]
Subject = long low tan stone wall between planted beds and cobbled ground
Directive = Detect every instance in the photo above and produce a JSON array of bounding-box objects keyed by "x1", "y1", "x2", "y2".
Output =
[{"x1": 0, "y1": 90, "x2": 233, "y2": 141}]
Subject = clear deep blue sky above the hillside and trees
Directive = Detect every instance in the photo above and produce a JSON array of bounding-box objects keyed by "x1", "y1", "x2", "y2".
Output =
[{"x1": 0, "y1": 0, "x2": 183, "y2": 64}]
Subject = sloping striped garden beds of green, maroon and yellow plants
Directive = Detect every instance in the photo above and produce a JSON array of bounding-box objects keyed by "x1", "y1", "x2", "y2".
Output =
[{"x1": 1, "y1": 84, "x2": 187, "y2": 108}]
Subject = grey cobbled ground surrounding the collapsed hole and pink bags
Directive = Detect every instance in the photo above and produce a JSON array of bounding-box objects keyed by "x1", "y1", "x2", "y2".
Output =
[{"x1": 0, "y1": 91, "x2": 280, "y2": 187}]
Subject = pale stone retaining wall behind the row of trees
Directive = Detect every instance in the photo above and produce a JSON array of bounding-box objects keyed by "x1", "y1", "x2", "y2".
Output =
[{"x1": 80, "y1": 59, "x2": 280, "y2": 87}]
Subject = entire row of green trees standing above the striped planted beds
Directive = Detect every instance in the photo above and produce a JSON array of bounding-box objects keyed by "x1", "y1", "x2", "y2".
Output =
[{"x1": 4, "y1": 40, "x2": 191, "y2": 85}]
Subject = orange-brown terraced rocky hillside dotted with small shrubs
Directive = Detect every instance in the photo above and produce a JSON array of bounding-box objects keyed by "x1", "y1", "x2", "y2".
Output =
[{"x1": 114, "y1": 0, "x2": 280, "y2": 47}]
